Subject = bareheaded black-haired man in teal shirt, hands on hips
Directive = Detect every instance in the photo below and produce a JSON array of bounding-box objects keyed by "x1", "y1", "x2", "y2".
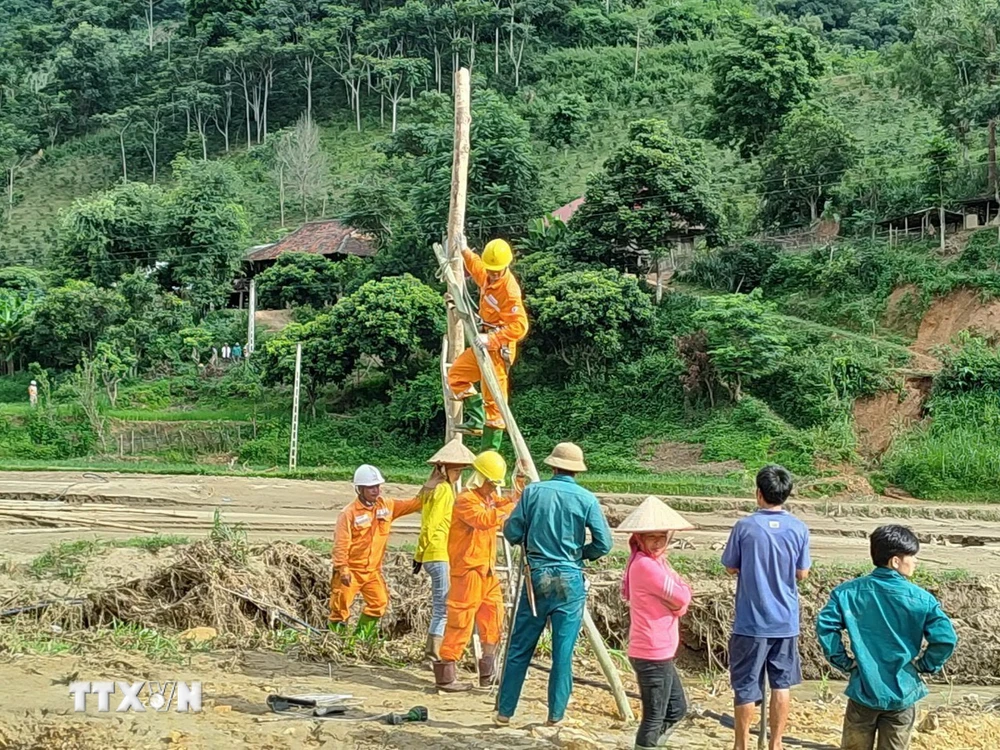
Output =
[{"x1": 816, "y1": 525, "x2": 958, "y2": 750}]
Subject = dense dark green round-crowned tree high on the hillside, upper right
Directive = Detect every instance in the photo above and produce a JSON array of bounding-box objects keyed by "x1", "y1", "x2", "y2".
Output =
[{"x1": 708, "y1": 19, "x2": 823, "y2": 156}]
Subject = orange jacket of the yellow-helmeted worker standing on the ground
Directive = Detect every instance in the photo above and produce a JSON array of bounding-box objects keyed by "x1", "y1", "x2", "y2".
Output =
[{"x1": 448, "y1": 490, "x2": 516, "y2": 576}]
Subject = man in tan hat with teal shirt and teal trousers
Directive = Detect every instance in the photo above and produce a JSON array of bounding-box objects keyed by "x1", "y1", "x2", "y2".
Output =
[{"x1": 496, "y1": 443, "x2": 612, "y2": 725}]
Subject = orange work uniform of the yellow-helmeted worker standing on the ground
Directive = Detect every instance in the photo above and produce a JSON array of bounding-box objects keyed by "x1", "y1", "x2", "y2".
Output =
[{"x1": 441, "y1": 490, "x2": 515, "y2": 661}]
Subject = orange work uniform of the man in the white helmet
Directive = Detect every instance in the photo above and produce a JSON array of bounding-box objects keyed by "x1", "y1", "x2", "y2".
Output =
[{"x1": 330, "y1": 497, "x2": 420, "y2": 622}]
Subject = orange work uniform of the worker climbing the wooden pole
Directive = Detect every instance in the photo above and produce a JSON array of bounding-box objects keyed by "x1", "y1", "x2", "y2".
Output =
[{"x1": 448, "y1": 250, "x2": 528, "y2": 430}]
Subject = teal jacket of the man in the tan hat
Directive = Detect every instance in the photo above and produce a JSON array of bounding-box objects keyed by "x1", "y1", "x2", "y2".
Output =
[{"x1": 503, "y1": 475, "x2": 611, "y2": 571}]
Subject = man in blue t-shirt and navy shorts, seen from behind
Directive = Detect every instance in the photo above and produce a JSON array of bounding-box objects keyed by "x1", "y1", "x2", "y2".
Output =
[{"x1": 722, "y1": 466, "x2": 811, "y2": 750}]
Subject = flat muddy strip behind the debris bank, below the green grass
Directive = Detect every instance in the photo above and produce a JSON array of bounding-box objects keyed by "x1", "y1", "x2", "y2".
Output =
[{"x1": 0, "y1": 472, "x2": 1000, "y2": 574}]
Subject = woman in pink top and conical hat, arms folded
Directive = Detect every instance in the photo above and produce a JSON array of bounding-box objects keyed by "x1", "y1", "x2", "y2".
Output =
[{"x1": 616, "y1": 497, "x2": 694, "y2": 750}]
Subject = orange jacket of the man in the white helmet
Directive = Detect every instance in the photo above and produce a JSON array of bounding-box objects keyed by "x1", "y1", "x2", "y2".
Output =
[{"x1": 333, "y1": 497, "x2": 420, "y2": 575}]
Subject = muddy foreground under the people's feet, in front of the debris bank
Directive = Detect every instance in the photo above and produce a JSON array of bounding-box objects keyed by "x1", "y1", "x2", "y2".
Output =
[{"x1": 0, "y1": 636, "x2": 1000, "y2": 750}]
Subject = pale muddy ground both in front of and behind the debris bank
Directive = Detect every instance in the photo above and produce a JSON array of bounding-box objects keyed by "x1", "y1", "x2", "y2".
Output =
[{"x1": 0, "y1": 472, "x2": 1000, "y2": 750}]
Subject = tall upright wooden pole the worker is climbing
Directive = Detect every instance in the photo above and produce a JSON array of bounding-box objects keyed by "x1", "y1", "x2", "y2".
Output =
[{"x1": 444, "y1": 68, "x2": 472, "y2": 442}]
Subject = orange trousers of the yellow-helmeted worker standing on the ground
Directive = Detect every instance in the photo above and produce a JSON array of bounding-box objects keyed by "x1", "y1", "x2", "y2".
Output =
[{"x1": 441, "y1": 570, "x2": 503, "y2": 661}]
